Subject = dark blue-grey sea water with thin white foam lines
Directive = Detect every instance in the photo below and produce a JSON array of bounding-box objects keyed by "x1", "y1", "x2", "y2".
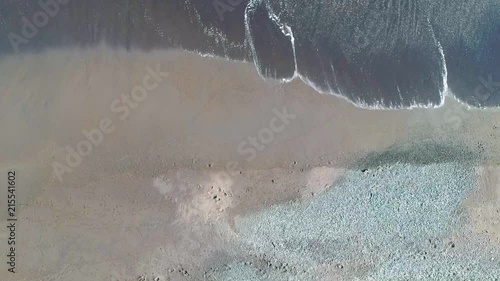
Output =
[{"x1": 0, "y1": 0, "x2": 500, "y2": 108}]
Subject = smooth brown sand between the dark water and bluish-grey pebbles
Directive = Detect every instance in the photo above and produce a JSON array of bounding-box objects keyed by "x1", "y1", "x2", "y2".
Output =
[{"x1": 0, "y1": 46, "x2": 500, "y2": 281}]
